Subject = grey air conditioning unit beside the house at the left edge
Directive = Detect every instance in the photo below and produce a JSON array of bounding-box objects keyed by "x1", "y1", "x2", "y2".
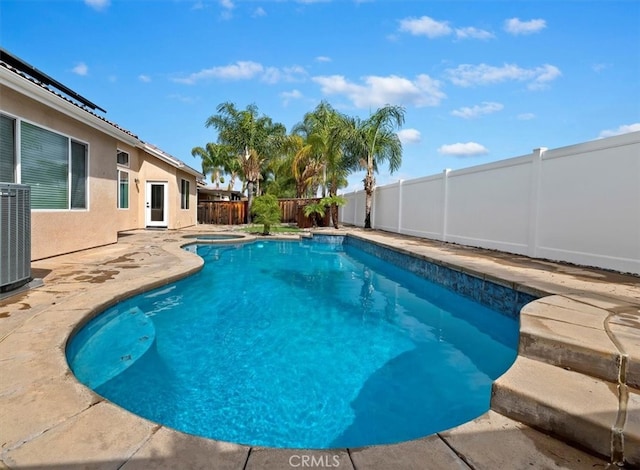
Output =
[{"x1": 0, "y1": 183, "x2": 31, "y2": 292}]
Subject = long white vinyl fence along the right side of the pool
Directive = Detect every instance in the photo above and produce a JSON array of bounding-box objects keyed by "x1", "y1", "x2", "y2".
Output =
[{"x1": 340, "y1": 132, "x2": 640, "y2": 274}]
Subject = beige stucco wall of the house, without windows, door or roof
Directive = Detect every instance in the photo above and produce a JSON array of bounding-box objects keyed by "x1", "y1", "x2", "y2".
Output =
[{"x1": 0, "y1": 85, "x2": 197, "y2": 260}]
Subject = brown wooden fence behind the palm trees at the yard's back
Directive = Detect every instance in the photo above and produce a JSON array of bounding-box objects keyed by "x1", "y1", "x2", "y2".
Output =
[{"x1": 198, "y1": 199, "x2": 330, "y2": 228}]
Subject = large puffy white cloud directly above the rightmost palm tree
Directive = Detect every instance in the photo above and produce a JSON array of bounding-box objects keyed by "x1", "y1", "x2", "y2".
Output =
[{"x1": 313, "y1": 74, "x2": 446, "y2": 108}]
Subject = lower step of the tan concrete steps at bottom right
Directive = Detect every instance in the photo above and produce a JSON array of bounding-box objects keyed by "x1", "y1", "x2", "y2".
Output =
[{"x1": 491, "y1": 356, "x2": 640, "y2": 465}]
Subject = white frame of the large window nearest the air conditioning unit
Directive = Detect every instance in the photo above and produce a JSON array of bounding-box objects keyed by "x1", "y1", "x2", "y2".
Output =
[{"x1": 0, "y1": 110, "x2": 91, "y2": 212}]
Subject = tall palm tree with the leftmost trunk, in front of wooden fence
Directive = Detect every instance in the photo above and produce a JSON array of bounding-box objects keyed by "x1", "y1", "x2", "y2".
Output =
[{"x1": 205, "y1": 102, "x2": 286, "y2": 222}]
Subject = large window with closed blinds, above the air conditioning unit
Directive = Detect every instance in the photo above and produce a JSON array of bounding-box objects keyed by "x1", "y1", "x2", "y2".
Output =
[{"x1": 12, "y1": 116, "x2": 88, "y2": 209}]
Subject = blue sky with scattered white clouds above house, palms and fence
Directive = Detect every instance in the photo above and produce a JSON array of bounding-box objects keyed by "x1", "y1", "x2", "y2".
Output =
[{"x1": 0, "y1": 0, "x2": 640, "y2": 193}]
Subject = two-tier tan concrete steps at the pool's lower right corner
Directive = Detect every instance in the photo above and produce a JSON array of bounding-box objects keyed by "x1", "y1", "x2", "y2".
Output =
[{"x1": 500, "y1": 294, "x2": 640, "y2": 465}]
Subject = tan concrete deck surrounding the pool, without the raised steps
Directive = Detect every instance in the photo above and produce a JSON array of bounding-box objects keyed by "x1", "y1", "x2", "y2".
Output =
[{"x1": 0, "y1": 226, "x2": 640, "y2": 469}]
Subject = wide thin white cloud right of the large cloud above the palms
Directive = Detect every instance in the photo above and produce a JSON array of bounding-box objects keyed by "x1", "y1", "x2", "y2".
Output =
[{"x1": 447, "y1": 64, "x2": 562, "y2": 90}]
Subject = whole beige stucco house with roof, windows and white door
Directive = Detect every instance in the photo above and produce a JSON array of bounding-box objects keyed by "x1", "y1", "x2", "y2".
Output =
[{"x1": 0, "y1": 51, "x2": 203, "y2": 260}]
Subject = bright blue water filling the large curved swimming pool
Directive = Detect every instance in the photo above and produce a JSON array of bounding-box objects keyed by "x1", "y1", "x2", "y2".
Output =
[{"x1": 67, "y1": 241, "x2": 518, "y2": 448}]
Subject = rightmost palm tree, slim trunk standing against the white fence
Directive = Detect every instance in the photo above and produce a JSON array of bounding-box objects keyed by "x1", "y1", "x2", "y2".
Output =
[{"x1": 345, "y1": 105, "x2": 404, "y2": 228}]
